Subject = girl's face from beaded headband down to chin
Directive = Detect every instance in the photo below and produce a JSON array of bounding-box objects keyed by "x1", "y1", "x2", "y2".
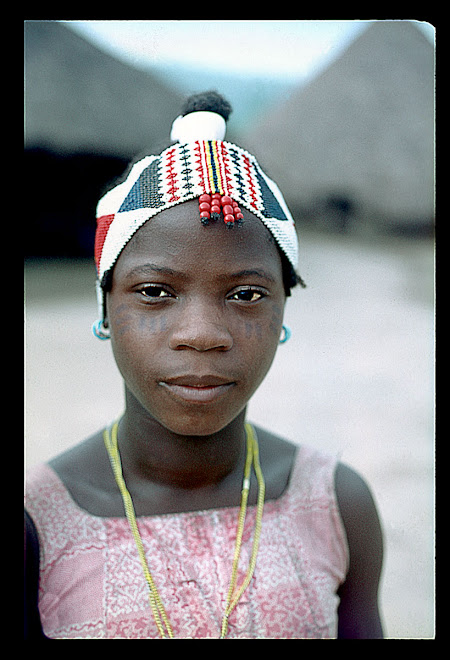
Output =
[{"x1": 107, "y1": 200, "x2": 285, "y2": 435}]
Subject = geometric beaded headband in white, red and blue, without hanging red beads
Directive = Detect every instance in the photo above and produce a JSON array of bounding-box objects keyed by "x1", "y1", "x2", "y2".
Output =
[{"x1": 95, "y1": 140, "x2": 298, "y2": 290}]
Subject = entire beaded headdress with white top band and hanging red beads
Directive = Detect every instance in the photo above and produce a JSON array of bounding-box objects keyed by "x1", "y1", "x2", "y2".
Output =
[{"x1": 95, "y1": 91, "x2": 298, "y2": 336}]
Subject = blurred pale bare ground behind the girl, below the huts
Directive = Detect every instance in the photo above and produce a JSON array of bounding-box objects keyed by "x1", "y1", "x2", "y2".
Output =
[{"x1": 25, "y1": 233, "x2": 435, "y2": 639}]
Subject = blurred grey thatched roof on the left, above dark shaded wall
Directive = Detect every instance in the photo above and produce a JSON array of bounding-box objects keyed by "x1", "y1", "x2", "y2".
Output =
[{"x1": 25, "y1": 21, "x2": 182, "y2": 157}]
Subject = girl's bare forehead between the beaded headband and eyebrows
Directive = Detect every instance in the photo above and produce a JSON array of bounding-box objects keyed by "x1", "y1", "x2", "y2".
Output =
[{"x1": 116, "y1": 200, "x2": 281, "y2": 276}]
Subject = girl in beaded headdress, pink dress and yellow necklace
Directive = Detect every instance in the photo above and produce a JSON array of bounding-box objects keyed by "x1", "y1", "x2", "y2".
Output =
[{"x1": 25, "y1": 93, "x2": 382, "y2": 639}]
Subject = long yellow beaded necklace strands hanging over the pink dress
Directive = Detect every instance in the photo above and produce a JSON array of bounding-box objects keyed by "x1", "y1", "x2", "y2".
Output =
[{"x1": 103, "y1": 422, "x2": 265, "y2": 639}]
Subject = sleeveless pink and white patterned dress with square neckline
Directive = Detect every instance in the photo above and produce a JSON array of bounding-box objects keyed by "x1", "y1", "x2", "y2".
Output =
[{"x1": 26, "y1": 446, "x2": 348, "y2": 639}]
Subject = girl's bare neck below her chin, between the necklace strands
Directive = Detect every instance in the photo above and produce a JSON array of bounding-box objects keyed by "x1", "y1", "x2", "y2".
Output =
[{"x1": 118, "y1": 391, "x2": 245, "y2": 489}]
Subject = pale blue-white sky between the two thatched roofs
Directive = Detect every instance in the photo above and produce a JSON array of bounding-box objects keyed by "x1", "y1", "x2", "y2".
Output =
[{"x1": 65, "y1": 20, "x2": 434, "y2": 79}]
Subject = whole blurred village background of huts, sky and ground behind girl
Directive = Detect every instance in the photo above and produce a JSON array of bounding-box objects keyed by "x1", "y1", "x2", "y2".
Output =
[{"x1": 23, "y1": 20, "x2": 435, "y2": 639}]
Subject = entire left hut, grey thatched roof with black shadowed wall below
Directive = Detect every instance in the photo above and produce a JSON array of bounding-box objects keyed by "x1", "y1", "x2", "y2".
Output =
[{"x1": 24, "y1": 21, "x2": 183, "y2": 257}]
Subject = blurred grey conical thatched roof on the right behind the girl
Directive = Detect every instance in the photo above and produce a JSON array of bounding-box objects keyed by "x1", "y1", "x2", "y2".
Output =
[{"x1": 245, "y1": 21, "x2": 434, "y2": 231}]
